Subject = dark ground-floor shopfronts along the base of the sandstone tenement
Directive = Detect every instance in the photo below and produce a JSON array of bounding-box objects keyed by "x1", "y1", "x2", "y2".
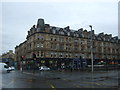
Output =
[{"x1": 17, "y1": 58, "x2": 120, "y2": 70}]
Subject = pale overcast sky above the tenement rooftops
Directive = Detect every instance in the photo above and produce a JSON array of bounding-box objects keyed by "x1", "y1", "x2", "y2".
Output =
[{"x1": 0, "y1": 0, "x2": 118, "y2": 55}]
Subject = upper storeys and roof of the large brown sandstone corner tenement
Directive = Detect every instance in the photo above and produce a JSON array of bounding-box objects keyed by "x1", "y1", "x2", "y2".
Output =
[{"x1": 15, "y1": 19, "x2": 120, "y2": 67}]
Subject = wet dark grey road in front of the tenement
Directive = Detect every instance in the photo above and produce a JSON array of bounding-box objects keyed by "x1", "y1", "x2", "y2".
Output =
[{"x1": 2, "y1": 70, "x2": 120, "y2": 89}]
